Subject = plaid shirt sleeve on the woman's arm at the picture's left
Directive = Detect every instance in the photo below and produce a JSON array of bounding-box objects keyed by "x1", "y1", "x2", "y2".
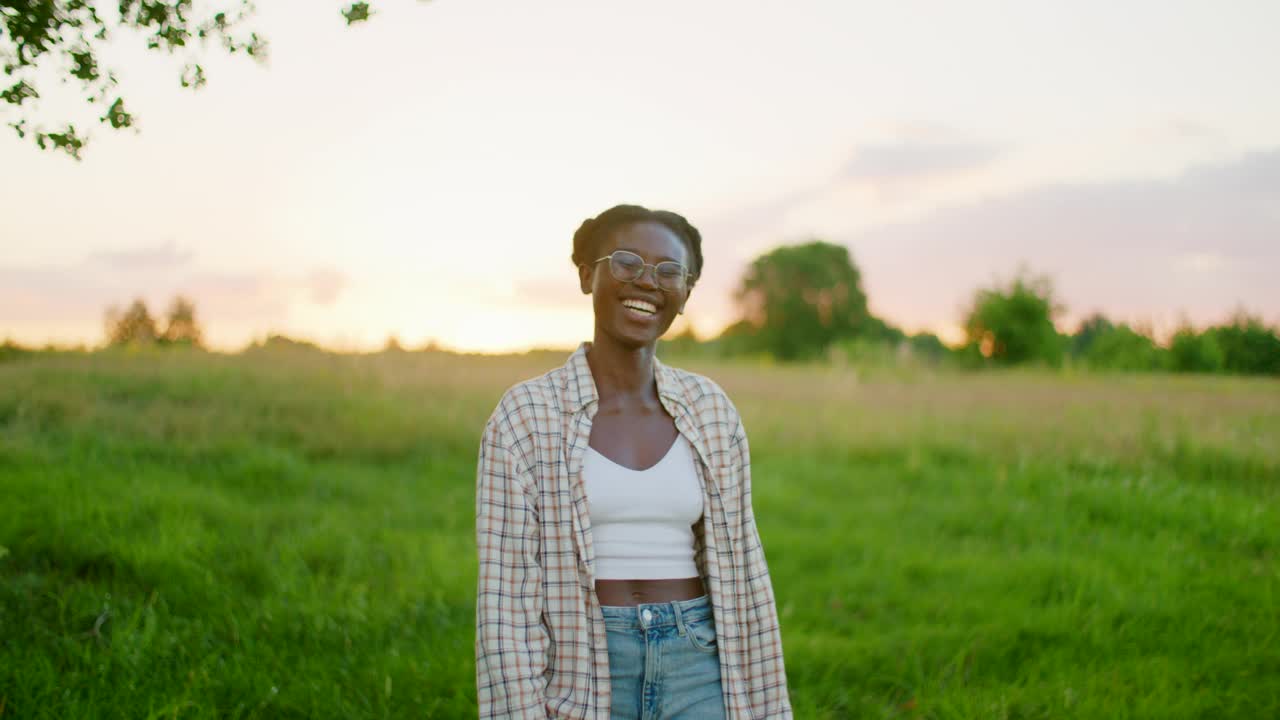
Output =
[{"x1": 476, "y1": 418, "x2": 549, "y2": 720}]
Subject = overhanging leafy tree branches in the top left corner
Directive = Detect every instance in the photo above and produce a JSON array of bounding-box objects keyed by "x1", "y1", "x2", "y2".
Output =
[{"x1": 0, "y1": 0, "x2": 384, "y2": 160}]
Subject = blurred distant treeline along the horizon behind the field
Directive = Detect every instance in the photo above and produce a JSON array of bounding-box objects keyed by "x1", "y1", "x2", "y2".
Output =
[{"x1": 0, "y1": 241, "x2": 1280, "y2": 375}]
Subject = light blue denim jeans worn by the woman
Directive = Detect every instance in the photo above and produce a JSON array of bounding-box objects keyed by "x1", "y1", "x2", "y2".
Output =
[{"x1": 600, "y1": 596, "x2": 724, "y2": 720}]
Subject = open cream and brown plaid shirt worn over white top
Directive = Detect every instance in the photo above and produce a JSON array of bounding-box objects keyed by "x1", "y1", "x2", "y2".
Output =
[{"x1": 476, "y1": 342, "x2": 791, "y2": 720}]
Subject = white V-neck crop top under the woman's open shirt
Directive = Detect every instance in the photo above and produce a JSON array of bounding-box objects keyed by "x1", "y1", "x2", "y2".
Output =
[{"x1": 582, "y1": 434, "x2": 703, "y2": 580}]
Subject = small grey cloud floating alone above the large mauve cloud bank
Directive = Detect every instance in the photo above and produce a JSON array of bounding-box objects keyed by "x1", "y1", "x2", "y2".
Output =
[{"x1": 841, "y1": 140, "x2": 1002, "y2": 183}]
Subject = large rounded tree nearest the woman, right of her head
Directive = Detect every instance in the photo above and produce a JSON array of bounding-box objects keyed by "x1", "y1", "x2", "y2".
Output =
[{"x1": 735, "y1": 241, "x2": 868, "y2": 360}]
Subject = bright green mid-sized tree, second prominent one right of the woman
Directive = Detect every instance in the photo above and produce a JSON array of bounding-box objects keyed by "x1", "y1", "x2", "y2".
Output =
[{"x1": 965, "y1": 270, "x2": 1064, "y2": 366}]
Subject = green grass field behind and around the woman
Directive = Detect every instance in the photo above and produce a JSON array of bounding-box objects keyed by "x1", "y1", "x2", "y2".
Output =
[{"x1": 0, "y1": 352, "x2": 1280, "y2": 719}]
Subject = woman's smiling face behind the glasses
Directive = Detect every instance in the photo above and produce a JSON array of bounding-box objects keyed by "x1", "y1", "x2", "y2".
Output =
[{"x1": 579, "y1": 222, "x2": 692, "y2": 347}]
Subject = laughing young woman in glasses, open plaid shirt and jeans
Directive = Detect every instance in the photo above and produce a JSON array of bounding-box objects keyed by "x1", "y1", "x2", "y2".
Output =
[{"x1": 476, "y1": 205, "x2": 791, "y2": 720}]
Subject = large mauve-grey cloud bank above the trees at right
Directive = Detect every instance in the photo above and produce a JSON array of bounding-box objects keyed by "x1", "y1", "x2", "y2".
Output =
[{"x1": 846, "y1": 150, "x2": 1280, "y2": 333}]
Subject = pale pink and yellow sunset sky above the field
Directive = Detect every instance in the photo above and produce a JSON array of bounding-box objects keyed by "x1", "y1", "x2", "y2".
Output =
[{"x1": 0, "y1": 0, "x2": 1280, "y2": 351}]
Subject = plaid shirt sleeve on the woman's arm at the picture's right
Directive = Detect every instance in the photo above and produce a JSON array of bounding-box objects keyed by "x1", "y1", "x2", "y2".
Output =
[{"x1": 733, "y1": 420, "x2": 792, "y2": 719}]
